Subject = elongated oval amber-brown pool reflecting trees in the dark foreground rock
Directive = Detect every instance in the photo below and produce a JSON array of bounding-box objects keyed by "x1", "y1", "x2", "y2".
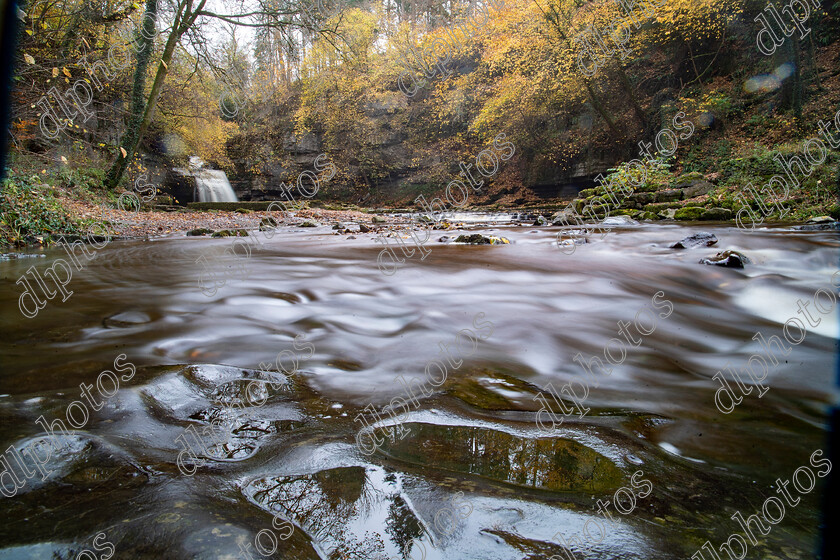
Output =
[{"x1": 379, "y1": 422, "x2": 624, "y2": 493}]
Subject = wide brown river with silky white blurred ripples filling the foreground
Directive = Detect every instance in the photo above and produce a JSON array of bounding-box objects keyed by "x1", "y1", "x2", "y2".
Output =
[{"x1": 0, "y1": 223, "x2": 838, "y2": 560}]
